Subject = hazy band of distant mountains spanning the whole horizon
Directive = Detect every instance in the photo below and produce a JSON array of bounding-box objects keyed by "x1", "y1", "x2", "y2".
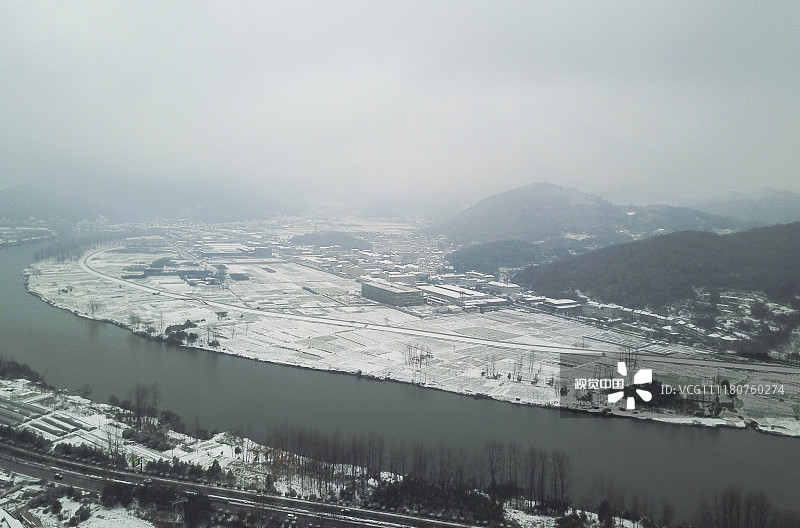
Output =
[{"x1": 6, "y1": 178, "x2": 800, "y2": 241}]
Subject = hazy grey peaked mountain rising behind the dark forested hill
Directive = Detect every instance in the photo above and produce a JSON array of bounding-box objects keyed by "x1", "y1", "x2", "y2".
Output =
[{"x1": 435, "y1": 183, "x2": 743, "y2": 246}]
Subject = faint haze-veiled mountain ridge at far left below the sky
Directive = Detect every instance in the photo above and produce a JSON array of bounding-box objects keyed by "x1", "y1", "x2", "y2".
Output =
[{"x1": 0, "y1": 179, "x2": 297, "y2": 222}]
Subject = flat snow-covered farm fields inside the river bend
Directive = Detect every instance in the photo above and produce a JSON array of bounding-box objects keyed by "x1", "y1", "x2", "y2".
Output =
[{"x1": 27, "y1": 248, "x2": 800, "y2": 435}]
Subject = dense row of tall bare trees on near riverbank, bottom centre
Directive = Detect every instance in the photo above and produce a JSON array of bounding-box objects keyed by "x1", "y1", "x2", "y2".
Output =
[{"x1": 253, "y1": 424, "x2": 571, "y2": 510}]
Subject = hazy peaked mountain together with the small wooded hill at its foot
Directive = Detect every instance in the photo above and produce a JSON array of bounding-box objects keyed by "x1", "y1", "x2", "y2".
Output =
[{"x1": 434, "y1": 183, "x2": 800, "y2": 274}]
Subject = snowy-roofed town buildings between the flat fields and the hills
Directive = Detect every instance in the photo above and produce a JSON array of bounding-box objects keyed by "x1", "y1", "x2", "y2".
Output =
[{"x1": 131, "y1": 219, "x2": 791, "y2": 350}]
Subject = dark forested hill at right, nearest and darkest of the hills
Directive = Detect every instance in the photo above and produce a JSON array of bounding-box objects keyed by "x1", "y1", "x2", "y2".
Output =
[{"x1": 515, "y1": 222, "x2": 800, "y2": 308}]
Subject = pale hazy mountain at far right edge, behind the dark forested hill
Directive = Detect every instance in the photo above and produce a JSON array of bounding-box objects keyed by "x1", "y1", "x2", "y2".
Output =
[{"x1": 692, "y1": 187, "x2": 800, "y2": 225}]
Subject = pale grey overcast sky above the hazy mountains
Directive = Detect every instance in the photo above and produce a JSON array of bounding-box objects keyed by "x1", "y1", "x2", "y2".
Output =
[{"x1": 0, "y1": 0, "x2": 800, "y2": 203}]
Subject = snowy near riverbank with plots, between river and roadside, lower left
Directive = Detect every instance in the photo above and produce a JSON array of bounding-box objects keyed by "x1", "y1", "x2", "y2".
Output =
[{"x1": 0, "y1": 379, "x2": 576, "y2": 527}]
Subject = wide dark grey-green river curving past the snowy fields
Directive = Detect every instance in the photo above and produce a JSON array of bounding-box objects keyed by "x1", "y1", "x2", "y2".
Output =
[{"x1": 0, "y1": 244, "x2": 800, "y2": 518}]
